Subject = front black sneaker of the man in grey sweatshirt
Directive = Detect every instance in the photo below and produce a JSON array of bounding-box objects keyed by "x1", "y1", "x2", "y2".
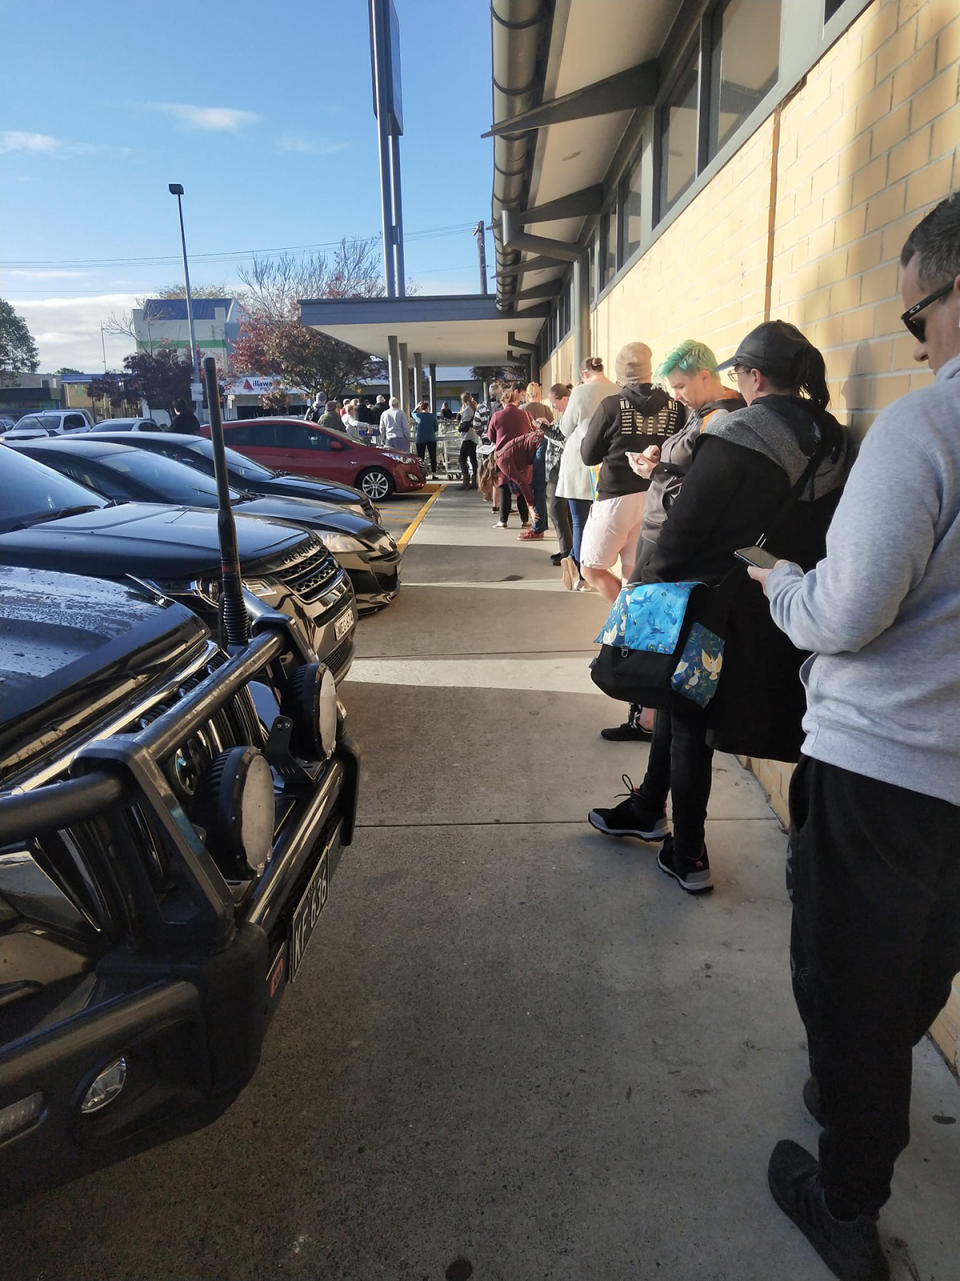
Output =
[{"x1": 766, "y1": 1139, "x2": 890, "y2": 1281}]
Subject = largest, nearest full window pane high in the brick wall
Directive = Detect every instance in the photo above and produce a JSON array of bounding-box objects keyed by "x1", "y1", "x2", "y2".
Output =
[{"x1": 702, "y1": 0, "x2": 781, "y2": 156}]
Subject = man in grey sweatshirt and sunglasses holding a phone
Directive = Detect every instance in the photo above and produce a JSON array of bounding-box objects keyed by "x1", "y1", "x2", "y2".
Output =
[{"x1": 750, "y1": 192, "x2": 960, "y2": 1281}]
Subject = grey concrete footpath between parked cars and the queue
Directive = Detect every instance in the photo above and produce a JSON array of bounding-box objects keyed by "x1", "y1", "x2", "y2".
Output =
[{"x1": 0, "y1": 487, "x2": 960, "y2": 1281}]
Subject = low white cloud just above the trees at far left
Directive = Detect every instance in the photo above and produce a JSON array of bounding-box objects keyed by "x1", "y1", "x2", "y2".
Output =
[{"x1": 9, "y1": 293, "x2": 138, "y2": 374}]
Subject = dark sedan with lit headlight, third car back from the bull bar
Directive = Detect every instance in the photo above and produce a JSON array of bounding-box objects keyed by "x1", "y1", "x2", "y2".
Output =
[{"x1": 17, "y1": 436, "x2": 400, "y2": 612}]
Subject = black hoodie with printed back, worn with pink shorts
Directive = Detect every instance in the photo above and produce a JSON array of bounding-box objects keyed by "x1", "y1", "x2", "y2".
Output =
[{"x1": 581, "y1": 383, "x2": 686, "y2": 498}]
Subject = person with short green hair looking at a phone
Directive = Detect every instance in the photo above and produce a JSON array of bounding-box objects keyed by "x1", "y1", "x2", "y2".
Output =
[{"x1": 591, "y1": 338, "x2": 745, "y2": 748}]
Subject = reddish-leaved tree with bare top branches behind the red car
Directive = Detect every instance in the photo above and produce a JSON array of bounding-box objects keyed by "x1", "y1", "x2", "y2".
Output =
[{"x1": 233, "y1": 240, "x2": 383, "y2": 397}]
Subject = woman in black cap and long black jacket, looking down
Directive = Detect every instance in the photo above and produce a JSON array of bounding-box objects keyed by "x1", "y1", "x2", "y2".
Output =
[{"x1": 591, "y1": 320, "x2": 852, "y2": 894}]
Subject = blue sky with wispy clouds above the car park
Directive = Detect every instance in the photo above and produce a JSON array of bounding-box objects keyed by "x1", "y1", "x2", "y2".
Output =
[{"x1": 0, "y1": 0, "x2": 492, "y2": 371}]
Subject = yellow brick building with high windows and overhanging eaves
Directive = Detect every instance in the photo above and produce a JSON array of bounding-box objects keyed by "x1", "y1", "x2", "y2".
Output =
[{"x1": 493, "y1": 0, "x2": 960, "y2": 1067}]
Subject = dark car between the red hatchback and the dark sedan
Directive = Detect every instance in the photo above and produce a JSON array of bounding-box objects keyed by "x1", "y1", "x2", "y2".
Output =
[{"x1": 83, "y1": 423, "x2": 382, "y2": 525}]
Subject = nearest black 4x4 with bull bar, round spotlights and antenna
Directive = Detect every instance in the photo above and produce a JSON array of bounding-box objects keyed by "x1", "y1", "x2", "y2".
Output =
[{"x1": 0, "y1": 561, "x2": 358, "y2": 1203}]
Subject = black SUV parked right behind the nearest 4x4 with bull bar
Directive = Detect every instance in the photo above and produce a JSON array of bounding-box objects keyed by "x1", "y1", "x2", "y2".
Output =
[{"x1": 0, "y1": 445, "x2": 356, "y2": 681}]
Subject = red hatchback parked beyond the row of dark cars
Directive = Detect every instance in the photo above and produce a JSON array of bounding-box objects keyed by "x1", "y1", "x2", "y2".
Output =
[{"x1": 210, "y1": 418, "x2": 424, "y2": 502}]
